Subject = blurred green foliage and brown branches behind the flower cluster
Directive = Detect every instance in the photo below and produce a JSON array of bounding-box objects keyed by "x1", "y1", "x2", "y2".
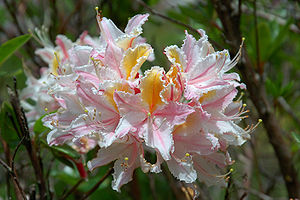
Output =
[{"x1": 0, "y1": 0, "x2": 300, "y2": 200}]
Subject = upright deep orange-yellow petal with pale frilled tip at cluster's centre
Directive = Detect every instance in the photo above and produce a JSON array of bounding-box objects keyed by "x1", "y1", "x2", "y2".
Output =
[{"x1": 140, "y1": 67, "x2": 164, "y2": 113}]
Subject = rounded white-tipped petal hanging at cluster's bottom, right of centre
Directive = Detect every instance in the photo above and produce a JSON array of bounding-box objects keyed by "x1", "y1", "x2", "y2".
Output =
[{"x1": 167, "y1": 156, "x2": 197, "y2": 183}]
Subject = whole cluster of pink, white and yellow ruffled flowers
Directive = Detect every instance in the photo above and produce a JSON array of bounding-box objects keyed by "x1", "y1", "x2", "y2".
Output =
[{"x1": 24, "y1": 10, "x2": 252, "y2": 191}]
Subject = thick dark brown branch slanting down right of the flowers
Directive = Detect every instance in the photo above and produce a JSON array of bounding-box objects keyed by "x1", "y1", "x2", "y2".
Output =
[{"x1": 213, "y1": 0, "x2": 300, "y2": 198}]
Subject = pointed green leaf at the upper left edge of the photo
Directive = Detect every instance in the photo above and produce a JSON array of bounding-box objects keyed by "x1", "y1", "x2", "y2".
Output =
[{"x1": 0, "y1": 34, "x2": 31, "y2": 66}]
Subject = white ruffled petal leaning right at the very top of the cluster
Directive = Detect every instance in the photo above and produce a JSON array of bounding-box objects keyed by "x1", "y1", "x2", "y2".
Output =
[{"x1": 125, "y1": 13, "x2": 149, "y2": 35}]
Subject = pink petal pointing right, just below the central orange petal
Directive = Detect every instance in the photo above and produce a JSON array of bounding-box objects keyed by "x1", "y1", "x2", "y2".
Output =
[{"x1": 152, "y1": 102, "x2": 194, "y2": 126}]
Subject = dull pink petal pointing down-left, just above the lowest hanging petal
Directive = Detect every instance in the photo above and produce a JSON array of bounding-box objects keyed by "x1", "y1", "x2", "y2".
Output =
[{"x1": 87, "y1": 143, "x2": 131, "y2": 171}]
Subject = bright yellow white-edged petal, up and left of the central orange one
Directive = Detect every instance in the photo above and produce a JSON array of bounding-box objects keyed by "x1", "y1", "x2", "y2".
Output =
[{"x1": 121, "y1": 44, "x2": 152, "y2": 80}]
